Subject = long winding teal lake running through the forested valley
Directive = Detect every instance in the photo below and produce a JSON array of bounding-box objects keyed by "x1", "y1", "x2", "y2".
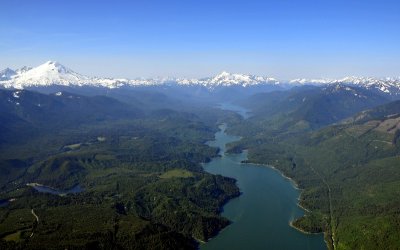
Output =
[{"x1": 200, "y1": 106, "x2": 327, "y2": 250}]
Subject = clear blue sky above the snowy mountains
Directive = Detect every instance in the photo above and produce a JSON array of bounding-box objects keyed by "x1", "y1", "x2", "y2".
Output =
[{"x1": 0, "y1": 0, "x2": 400, "y2": 79}]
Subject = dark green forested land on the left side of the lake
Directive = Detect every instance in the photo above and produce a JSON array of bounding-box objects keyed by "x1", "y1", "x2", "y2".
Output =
[{"x1": 0, "y1": 91, "x2": 239, "y2": 249}]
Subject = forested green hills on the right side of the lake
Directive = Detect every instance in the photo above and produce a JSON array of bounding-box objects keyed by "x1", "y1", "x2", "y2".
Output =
[{"x1": 230, "y1": 87, "x2": 400, "y2": 249}]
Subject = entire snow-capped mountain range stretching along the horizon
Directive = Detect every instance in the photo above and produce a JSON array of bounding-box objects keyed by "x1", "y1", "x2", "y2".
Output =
[{"x1": 0, "y1": 61, "x2": 400, "y2": 95}]
